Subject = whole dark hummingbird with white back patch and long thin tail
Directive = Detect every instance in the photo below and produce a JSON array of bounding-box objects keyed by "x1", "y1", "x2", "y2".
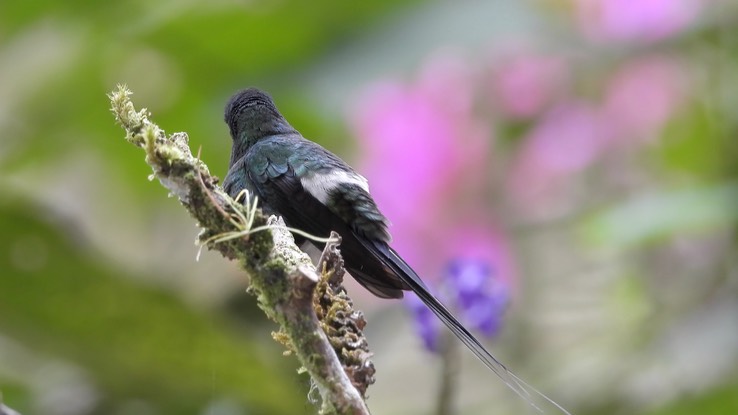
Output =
[{"x1": 223, "y1": 88, "x2": 569, "y2": 414}]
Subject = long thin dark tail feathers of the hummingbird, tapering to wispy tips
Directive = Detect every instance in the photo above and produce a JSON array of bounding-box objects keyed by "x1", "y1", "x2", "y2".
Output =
[{"x1": 374, "y1": 243, "x2": 571, "y2": 415}]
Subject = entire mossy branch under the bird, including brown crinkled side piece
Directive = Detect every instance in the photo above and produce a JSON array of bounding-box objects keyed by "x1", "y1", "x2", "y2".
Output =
[{"x1": 109, "y1": 85, "x2": 374, "y2": 414}]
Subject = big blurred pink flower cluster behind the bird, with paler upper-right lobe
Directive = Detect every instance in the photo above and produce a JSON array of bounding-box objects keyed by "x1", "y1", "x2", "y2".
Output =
[{"x1": 352, "y1": 53, "x2": 490, "y2": 273}]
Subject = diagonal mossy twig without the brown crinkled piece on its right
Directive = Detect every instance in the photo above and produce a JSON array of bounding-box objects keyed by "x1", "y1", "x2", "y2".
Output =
[{"x1": 109, "y1": 85, "x2": 373, "y2": 414}]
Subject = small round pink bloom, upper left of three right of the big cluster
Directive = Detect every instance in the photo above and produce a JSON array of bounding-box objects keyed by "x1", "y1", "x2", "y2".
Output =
[{"x1": 492, "y1": 55, "x2": 567, "y2": 118}]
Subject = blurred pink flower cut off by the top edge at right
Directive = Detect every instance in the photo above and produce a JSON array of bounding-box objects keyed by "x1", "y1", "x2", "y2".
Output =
[{"x1": 575, "y1": 0, "x2": 701, "y2": 41}]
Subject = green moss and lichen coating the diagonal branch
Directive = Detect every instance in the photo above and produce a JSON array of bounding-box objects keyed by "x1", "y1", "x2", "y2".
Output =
[{"x1": 107, "y1": 87, "x2": 370, "y2": 412}]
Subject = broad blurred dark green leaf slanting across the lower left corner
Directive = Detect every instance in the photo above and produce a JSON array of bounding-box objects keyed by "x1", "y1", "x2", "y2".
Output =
[{"x1": 0, "y1": 197, "x2": 301, "y2": 413}]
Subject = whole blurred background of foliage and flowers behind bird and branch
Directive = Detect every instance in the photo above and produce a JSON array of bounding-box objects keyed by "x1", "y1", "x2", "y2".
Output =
[{"x1": 0, "y1": 0, "x2": 738, "y2": 415}]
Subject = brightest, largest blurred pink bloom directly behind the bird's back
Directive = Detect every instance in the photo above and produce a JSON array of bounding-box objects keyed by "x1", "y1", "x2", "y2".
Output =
[{"x1": 354, "y1": 84, "x2": 459, "y2": 264}]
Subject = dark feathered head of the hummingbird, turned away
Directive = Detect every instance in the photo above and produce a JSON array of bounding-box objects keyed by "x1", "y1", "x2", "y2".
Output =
[{"x1": 225, "y1": 88, "x2": 294, "y2": 147}]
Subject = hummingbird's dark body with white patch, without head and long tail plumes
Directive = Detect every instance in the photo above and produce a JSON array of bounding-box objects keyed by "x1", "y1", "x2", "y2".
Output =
[{"x1": 223, "y1": 135, "x2": 407, "y2": 298}]
